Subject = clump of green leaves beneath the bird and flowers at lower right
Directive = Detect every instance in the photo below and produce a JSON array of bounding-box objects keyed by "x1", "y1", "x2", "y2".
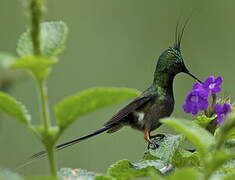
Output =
[{"x1": 56, "y1": 114, "x2": 235, "y2": 180}]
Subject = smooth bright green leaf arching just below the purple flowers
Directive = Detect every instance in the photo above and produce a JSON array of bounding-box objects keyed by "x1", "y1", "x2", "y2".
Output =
[{"x1": 161, "y1": 118, "x2": 215, "y2": 155}]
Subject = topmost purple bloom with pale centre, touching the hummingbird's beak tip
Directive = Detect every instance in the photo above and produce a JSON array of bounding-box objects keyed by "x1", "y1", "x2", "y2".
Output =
[{"x1": 203, "y1": 76, "x2": 223, "y2": 94}]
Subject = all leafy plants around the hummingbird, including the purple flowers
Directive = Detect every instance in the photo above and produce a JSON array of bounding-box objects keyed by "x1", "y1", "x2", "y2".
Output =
[{"x1": 0, "y1": 0, "x2": 235, "y2": 180}]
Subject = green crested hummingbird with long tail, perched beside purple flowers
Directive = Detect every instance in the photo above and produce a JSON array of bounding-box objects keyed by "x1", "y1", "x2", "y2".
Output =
[{"x1": 31, "y1": 22, "x2": 201, "y2": 158}]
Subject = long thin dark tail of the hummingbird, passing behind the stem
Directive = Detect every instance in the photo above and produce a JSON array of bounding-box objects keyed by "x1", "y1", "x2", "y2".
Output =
[{"x1": 17, "y1": 125, "x2": 113, "y2": 169}]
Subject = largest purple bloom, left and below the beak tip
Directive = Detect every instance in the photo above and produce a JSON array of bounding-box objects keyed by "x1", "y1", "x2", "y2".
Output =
[{"x1": 183, "y1": 83, "x2": 209, "y2": 115}]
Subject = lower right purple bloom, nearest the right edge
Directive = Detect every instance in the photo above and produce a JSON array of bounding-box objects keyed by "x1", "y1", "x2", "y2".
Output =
[{"x1": 214, "y1": 103, "x2": 231, "y2": 125}]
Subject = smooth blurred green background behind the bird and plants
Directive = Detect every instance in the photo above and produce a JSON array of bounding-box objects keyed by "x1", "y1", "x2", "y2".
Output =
[{"x1": 0, "y1": 0, "x2": 235, "y2": 175}]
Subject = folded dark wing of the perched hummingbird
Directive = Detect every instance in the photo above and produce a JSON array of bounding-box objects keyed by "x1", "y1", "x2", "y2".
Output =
[{"x1": 104, "y1": 93, "x2": 156, "y2": 126}]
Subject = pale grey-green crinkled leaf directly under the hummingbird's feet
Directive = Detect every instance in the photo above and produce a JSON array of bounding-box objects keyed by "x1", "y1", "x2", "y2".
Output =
[{"x1": 149, "y1": 134, "x2": 184, "y2": 164}]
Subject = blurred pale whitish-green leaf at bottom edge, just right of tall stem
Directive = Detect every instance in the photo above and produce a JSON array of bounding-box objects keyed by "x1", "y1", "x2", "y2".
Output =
[{"x1": 58, "y1": 168, "x2": 98, "y2": 180}]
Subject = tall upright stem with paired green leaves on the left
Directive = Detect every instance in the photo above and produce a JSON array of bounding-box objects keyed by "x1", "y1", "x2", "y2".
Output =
[{"x1": 0, "y1": 0, "x2": 140, "y2": 177}]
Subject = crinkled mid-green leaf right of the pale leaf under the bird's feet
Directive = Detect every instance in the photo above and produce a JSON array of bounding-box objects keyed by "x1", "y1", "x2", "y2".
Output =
[{"x1": 172, "y1": 149, "x2": 200, "y2": 168}]
